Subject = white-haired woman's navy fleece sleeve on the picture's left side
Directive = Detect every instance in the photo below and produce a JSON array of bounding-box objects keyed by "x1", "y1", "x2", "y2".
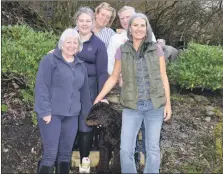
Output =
[{"x1": 35, "y1": 55, "x2": 53, "y2": 118}]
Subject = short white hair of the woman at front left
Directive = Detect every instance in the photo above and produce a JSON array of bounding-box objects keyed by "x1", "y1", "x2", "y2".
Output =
[{"x1": 58, "y1": 28, "x2": 83, "y2": 52}]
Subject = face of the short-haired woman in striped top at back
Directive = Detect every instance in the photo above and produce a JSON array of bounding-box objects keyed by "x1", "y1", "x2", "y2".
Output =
[{"x1": 95, "y1": 8, "x2": 112, "y2": 28}]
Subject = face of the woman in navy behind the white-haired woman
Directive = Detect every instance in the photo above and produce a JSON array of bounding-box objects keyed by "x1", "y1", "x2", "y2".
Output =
[{"x1": 77, "y1": 13, "x2": 93, "y2": 35}]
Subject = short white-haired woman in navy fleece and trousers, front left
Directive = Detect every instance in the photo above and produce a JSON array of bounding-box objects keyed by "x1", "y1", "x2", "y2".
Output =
[{"x1": 35, "y1": 29, "x2": 92, "y2": 174}]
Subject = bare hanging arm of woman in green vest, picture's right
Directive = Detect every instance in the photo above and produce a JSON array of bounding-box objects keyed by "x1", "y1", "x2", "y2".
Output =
[{"x1": 159, "y1": 56, "x2": 172, "y2": 121}]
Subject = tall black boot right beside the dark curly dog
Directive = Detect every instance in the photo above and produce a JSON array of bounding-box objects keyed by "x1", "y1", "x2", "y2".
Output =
[{"x1": 79, "y1": 131, "x2": 93, "y2": 163}]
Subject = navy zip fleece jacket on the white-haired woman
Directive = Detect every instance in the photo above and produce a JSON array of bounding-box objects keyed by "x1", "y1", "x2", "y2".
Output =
[{"x1": 35, "y1": 49, "x2": 92, "y2": 118}]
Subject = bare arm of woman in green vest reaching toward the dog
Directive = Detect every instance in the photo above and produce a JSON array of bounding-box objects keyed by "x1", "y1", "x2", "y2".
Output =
[{"x1": 94, "y1": 59, "x2": 121, "y2": 104}]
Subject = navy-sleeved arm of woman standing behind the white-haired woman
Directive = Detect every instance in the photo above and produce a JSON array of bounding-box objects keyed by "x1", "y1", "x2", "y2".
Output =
[{"x1": 96, "y1": 43, "x2": 108, "y2": 92}]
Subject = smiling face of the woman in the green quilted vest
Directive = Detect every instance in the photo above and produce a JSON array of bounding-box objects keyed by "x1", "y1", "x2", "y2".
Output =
[{"x1": 130, "y1": 18, "x2": 146, "y2": 40}]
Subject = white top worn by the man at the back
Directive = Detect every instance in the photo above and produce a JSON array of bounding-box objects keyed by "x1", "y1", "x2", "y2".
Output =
[{"x1": 107, "y1": 31, "x2": 156, "y2": 75}]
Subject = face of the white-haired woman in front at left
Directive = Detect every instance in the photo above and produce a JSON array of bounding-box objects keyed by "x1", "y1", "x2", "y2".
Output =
[{"x1": 62, "y1": 36, "x2": 79, "y2": 56}]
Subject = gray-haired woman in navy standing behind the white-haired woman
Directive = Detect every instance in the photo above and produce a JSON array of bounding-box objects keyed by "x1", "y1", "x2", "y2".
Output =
[{"x1": 75, "y1": 7, "x2": 108, "y2": 173}]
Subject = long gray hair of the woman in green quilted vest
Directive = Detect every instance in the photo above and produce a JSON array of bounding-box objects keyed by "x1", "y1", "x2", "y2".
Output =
[{"x1": 127, "y1": 13, "x2": 152, "y2": 43}]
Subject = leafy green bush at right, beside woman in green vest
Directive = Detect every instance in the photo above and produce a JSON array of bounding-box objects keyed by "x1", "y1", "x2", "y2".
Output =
[{"x1": 167, "y1": 43, "x2": 223, "y2": 90}]
